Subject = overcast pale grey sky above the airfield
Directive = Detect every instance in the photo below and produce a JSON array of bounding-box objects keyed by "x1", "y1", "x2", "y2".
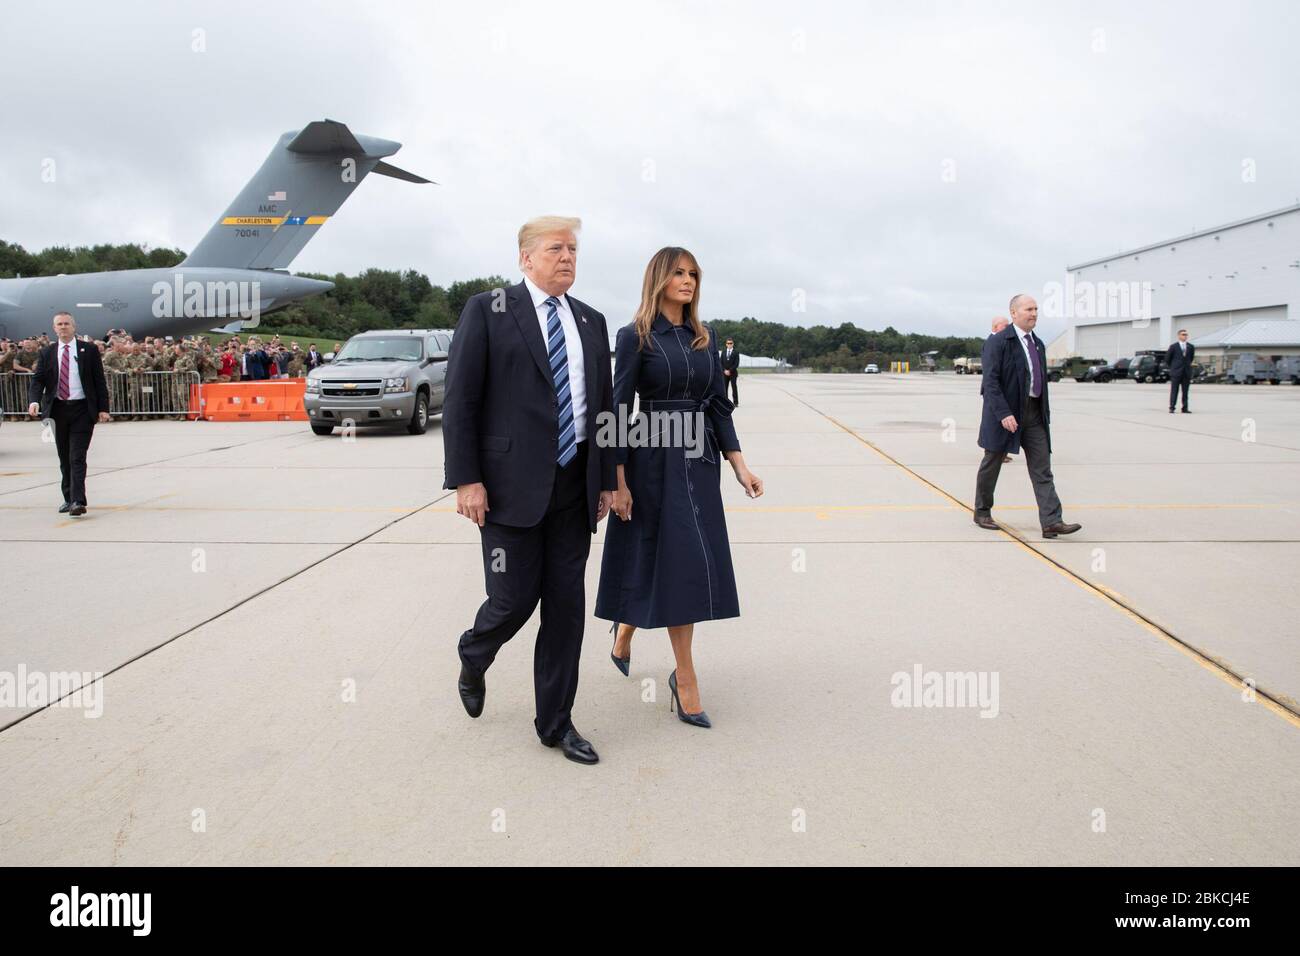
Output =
[{"x1": 0, "y1": 0, "x2": 1300, "y2": 334}]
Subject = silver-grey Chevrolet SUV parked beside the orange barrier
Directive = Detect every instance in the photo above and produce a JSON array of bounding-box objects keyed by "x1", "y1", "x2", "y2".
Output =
[{"x1": 303, "y1": 329, "x2": 452, "y2": 434}]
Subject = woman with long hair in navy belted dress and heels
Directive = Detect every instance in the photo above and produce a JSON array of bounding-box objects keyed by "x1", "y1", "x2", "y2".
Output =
[{"x1": 595, "y1": 247, "x2": 763, "y2": 727}]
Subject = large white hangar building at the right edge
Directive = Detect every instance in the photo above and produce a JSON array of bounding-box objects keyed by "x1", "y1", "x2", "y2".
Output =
[{"x1": 1044, "y1": 204, "x2": 1300, "y2": 364}]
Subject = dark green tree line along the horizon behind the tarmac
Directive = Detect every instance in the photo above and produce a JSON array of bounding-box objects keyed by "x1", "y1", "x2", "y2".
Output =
[{"x1": 0, "y1": 239, "x2": 983, "y2": 371}]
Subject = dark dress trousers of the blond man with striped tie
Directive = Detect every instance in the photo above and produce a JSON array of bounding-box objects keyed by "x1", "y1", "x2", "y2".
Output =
[{"x1": 460, "y1": 441, "x2": 592, "y2": 740}]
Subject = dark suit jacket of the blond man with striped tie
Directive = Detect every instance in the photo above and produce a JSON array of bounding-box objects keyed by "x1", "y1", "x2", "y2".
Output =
[{"x1": 442, "y1": 282, "x2": 616, "y2": 533}]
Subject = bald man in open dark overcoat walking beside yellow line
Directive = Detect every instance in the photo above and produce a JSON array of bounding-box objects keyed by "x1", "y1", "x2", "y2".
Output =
[{"x1": 975, "y1": 294, "x2": 1082, "y2": 537}]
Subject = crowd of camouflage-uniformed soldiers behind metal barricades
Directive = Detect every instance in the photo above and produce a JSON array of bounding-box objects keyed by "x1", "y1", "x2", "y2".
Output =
[{"x1": 0, "y1": 329, "x2": 325, "y2": 420}]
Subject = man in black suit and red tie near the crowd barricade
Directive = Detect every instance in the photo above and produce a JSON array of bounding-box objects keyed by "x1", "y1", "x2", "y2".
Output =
[{"x1": 27, "y1": 312, "x2": 108, "y2": 518}]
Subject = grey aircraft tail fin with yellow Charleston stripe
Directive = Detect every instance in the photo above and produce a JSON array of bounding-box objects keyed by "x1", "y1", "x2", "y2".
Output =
[{"x1": 181, "y1": 120, "x2": 429, "y2": 269}]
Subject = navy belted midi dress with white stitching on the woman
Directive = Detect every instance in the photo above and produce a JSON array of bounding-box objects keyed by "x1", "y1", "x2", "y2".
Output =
[{"x1": 595, "y1": 315, "x2": 740, "y2": 627}]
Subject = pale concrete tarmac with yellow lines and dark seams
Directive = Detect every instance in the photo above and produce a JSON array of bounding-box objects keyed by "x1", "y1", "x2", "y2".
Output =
[{"x1": 0, "y1": 373, "x2": 1300, "y2": 865}]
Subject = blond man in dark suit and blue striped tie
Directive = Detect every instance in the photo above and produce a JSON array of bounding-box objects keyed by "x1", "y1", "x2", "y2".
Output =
[{"x1": 442, "y1": 216, "x2": 618, "y2": 763}]
